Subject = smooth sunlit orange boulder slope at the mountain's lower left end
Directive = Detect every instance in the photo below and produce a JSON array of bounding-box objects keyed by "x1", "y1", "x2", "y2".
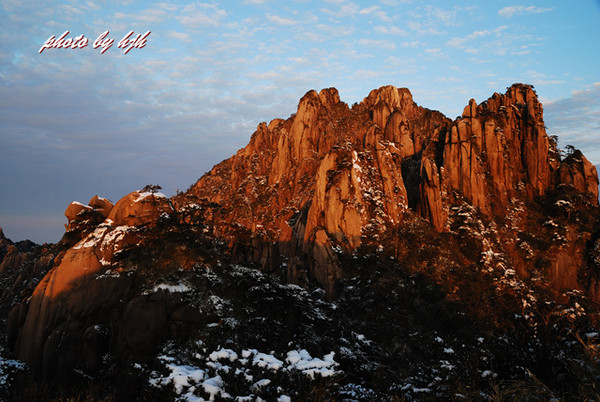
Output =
[{"x1": 16, "y1": 191, "x2": 172, "y2": 371}]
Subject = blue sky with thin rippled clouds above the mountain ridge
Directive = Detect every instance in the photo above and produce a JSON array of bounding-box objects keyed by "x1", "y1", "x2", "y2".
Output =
[{"x1": 0, "y1": 0, "x2": 600, "y2": 242}]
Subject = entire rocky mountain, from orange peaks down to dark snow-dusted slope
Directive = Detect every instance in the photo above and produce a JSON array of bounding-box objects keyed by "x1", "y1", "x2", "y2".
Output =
[{"x1": 0, "y1": 84, "x2": 600, "y2": 400}]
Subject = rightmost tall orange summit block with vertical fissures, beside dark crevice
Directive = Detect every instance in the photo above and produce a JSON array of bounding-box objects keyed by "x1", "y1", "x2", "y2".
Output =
[{"x1": 443, "y1": 86, "x2": 560, "y2": 217}]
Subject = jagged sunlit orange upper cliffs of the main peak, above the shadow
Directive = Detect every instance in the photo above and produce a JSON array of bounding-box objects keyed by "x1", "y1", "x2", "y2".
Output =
[{"x1": 182, "y1": 84, "x2": 598, "y2": 291}]
